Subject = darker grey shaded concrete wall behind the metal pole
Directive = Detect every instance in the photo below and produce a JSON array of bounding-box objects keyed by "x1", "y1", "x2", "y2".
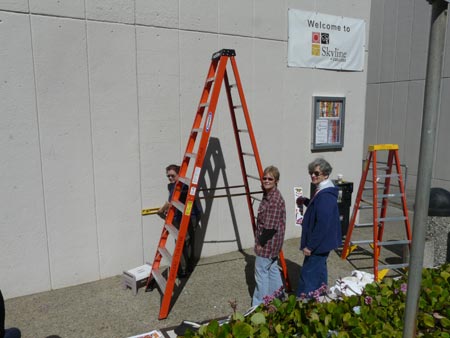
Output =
[{"x1": 364, "y1": 0, "x2": 450, "y2": 195}]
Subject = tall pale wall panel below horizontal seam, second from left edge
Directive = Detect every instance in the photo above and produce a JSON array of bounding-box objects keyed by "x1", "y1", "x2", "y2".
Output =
[{"x1": 32, "y1": 16, "x2": 99, "y2": 288}]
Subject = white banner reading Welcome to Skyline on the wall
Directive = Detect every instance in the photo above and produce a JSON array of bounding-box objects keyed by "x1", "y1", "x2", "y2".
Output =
[{"x1": 288, "y1": 9, "x2": 366, "y2": 71}]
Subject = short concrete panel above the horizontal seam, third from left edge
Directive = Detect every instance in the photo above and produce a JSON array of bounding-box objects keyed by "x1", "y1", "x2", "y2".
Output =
[{"x1": 86, "y1": 0, "x2": 135, "y2": 24}]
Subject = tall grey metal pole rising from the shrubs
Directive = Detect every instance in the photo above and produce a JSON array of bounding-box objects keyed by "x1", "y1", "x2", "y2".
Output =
[{"x1": 403, "y1": 0, "x2": 448, "y2": 338}]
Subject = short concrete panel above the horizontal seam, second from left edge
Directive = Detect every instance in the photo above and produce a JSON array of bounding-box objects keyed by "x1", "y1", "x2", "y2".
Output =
[{"x1": 29, "y1": 0, "x2": 85, "y2": 18}]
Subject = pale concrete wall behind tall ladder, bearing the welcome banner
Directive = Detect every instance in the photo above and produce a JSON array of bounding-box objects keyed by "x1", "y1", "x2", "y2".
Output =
[{"x1": 0, "y1": 0, "x2": 370, "y2": 298}]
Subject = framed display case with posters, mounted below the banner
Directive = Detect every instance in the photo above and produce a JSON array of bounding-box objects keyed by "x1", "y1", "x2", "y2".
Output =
[{"x1": 311, "y1": 96, "x2": 345, "y2": 150}]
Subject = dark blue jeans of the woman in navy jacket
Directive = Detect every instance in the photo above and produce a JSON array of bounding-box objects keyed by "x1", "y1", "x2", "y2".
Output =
[{"x1": 296, "y1": 252, "x2": 329, "y2": 297}]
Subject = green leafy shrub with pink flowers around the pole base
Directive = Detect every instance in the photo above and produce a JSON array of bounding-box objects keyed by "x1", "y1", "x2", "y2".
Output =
[{"x1": 185, "y1": 264, "x2": 450, "y2": 338}]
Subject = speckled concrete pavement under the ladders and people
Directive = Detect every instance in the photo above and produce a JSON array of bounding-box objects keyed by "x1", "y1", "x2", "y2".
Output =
[{"x1": 6, "y1": 203, "x2": 411, "y2": 338}]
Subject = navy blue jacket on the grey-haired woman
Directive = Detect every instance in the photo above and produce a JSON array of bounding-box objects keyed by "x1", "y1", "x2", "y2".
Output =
[{"x1": 300, "y1": 187, "x2": 342, "y2": 255}]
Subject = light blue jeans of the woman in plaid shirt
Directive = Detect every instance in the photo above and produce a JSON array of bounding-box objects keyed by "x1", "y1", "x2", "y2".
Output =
[{"x1": 252, "y1": 256, "x2": 283, "y2": 306}]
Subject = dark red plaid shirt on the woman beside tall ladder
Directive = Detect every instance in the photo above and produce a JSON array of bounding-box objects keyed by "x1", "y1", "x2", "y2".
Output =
[{"x1": 255, "y1": 188, "x2": 286, "y2": 258}]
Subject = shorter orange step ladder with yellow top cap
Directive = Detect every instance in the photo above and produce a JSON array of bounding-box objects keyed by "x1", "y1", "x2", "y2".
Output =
[{"x1": 341, "y1": 144, "x2": 411, "y2": 281}]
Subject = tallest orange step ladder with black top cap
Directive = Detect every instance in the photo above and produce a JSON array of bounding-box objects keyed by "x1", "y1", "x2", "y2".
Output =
[{"x1": 147, "y1": 49, "x2": 289, "y2": 319}]
